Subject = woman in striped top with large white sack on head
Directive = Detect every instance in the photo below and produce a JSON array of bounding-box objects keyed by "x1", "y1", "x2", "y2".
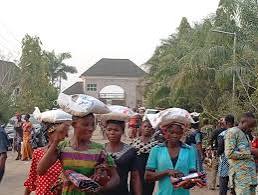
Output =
[{"x1": 37, "y1": 94, "x2": 119, "y2": 195}]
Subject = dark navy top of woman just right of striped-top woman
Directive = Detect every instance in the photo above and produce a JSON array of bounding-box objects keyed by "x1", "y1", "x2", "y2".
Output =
[{"x1": 103, "y1": 144, "x2": 138, "y2": 195}]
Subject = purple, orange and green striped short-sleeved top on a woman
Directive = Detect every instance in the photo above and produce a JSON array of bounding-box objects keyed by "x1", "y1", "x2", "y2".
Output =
[{"x1": 58, "y1": 140, "x2": 115, "y2": 195}]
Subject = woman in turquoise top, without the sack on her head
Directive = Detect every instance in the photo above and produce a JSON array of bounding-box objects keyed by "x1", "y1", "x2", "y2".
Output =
[{"x1": 145, "y1": 122, "x2": 196, "y2": 195}]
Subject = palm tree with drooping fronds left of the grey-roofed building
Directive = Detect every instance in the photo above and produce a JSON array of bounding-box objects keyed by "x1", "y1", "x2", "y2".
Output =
[{"x1": 46, "y1": 51, "x2": 77, "y2": 89}]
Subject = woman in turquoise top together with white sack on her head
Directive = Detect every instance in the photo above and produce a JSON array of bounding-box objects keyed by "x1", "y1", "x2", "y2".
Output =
[{"x1": 145, "y1": 108, "x2": 204, "y2": 195}]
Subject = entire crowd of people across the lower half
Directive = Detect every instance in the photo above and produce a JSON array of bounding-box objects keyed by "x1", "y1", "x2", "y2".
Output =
[{"x1": 0, "y1": 95, "x2": 258, "y2": 195}]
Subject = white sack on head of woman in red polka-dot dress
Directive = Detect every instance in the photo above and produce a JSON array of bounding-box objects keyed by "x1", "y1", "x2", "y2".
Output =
[{"x1": 33, "y1": 107, "x2": 72, "y2": 123}]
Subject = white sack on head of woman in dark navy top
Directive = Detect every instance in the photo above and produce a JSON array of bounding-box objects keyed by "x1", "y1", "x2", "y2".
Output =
[{"x1": 101, "y1": 105, "x2": 135, "y2": 122}]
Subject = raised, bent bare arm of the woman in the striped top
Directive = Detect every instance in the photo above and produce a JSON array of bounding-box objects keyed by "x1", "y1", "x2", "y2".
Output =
[{"x1": 37, "y1": 142, "x2": 59, "y2": 175}]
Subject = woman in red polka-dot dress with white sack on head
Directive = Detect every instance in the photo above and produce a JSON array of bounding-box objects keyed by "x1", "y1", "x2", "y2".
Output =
[{"x1": 24, "y1": 110, "x2": 72, "y2": 195}]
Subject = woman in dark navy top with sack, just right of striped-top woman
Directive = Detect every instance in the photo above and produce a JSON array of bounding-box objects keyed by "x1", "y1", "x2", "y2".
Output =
[{"x1": 102, "y1": 105, "x2": 142, "y2": 195}]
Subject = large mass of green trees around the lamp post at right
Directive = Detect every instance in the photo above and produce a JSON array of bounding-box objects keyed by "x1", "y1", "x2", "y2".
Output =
[{"x1": 145, "y1": 0, "x2": 258, "y2": 118}]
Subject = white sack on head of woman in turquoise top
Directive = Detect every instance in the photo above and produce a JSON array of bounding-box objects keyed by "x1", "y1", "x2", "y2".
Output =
[{"x1": 149, "y1": 108, "x2": 194, "y2": 128}]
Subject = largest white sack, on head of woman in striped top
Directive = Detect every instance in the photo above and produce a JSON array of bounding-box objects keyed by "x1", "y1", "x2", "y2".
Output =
[{"x1": 57, "y1": 93, "x2": 110, "y2": 117}]
